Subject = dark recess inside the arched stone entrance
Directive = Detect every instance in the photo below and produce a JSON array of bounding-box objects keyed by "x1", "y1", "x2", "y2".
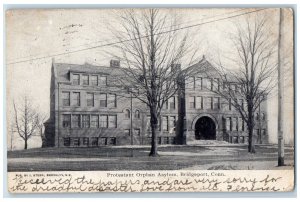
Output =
[{"x1": 195, "y1": 116, "x2": 216, "y2": 140}]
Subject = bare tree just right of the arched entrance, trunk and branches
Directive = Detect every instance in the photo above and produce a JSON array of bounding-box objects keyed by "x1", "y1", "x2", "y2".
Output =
[{"x1": 209, "y1": 15, "x2": 277, "y2": 153}]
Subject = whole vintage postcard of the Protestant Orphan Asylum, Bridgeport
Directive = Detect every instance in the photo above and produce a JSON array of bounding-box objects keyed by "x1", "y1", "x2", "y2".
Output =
[{"x1": 5, "y1": 7, "x2": 295, "y2": 193}]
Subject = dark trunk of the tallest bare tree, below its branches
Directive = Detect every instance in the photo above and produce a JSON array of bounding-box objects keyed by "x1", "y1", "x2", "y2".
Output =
[{"x1": 149, "y1": 107, "x2": 159, "y2": 157}]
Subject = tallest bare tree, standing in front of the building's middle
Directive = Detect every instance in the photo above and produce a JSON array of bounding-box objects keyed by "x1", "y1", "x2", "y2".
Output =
[{"x1": 112, "y1": 9, "x2": 197, "y2": 156}]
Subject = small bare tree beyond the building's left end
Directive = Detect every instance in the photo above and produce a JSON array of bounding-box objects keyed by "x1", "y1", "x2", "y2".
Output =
[{"x1": 13, "y1": 95, "x2": 44, "y2": 149}]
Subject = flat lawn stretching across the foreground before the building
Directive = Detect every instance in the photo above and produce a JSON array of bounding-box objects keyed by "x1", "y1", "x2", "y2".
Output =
[{"x1": 7, "y1": 145, "x2": 294, "y2": 171}]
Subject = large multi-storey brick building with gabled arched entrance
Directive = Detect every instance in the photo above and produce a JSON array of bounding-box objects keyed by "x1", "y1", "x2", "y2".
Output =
[{"x1": 44, "y1": 58, "x2": 268, "y2": 147}]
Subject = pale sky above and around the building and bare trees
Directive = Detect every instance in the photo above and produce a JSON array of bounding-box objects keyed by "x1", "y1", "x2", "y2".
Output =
[{"x1": 6, "y1": 8, "x2": 294, "y2": 149}]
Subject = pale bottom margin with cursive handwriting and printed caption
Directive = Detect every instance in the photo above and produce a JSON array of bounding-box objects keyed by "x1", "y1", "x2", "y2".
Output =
[{"x1": 9, "y1": 171, "x2": 293, "y2": 193}]
